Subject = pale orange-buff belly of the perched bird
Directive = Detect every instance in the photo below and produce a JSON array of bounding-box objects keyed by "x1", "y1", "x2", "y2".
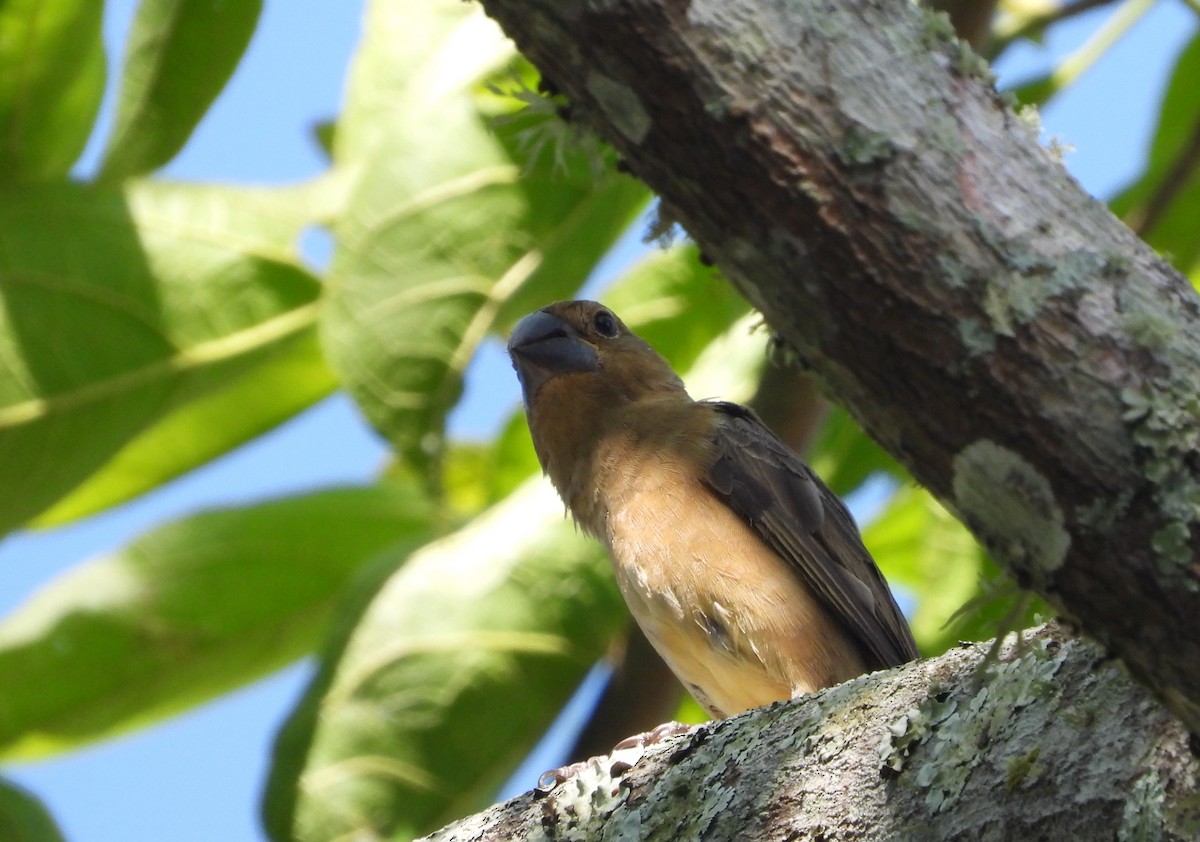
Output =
[{"x1": 606, "y1": 474, "x2": 864, "y2": 716}]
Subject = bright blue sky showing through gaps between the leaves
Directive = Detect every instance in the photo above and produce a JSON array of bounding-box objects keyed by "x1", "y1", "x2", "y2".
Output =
[{"x1": 0, "y1": 0, "x2": 1196, "y2": 842}]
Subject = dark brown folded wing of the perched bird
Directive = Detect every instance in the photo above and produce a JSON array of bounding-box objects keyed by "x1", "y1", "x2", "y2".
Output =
[{"x1": 707, "y1": 402, "x2": 918, "y2": 669}]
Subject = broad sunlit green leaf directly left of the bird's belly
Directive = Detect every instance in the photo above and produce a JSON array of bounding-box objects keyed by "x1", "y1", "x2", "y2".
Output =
[{"x1": 265, "y1": 481, "x2": 625, "y2": 841}]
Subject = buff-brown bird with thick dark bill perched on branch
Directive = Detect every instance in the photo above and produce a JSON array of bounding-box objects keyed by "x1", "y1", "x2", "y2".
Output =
[{"x1": 509, "y1": 301, "x2": 918, "y2": 717}]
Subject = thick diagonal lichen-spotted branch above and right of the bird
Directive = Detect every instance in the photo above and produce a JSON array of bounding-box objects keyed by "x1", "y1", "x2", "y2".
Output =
[{"x1": 484, "y1": 0, "x2": 1200, "y2": 732}]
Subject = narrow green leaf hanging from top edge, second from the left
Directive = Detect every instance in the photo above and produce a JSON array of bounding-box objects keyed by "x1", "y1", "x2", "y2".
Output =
[{"x1": 100, "y1": 0, "x2": 263, "y2": 182}]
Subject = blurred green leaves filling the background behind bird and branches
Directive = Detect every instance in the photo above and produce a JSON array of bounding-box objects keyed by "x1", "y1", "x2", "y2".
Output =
[{"x1": 0, "y1": 0, "x2": 1200, "y2": 840}]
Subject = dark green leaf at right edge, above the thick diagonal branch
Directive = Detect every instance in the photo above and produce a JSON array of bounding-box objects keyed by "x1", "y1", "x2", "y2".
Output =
[{"x1": 1110, "y1": 36, "x2": 1200, "y2": 275}]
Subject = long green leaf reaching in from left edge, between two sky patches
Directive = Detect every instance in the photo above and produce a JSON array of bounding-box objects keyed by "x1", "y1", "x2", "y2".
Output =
[{"x1": 0, "y1": 486, "x2": 432, "y2": 759}]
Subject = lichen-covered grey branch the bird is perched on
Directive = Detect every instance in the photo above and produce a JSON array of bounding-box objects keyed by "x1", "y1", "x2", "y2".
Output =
[{"x1": 428, "y1": 629, "x2": 1200, "y2": 842}]
